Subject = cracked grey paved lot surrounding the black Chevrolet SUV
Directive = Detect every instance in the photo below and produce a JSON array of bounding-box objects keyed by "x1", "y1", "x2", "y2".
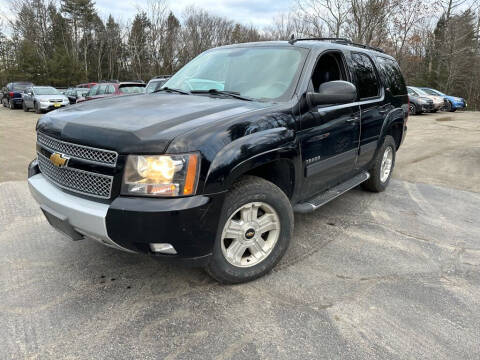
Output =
[{"x1": 0, "y1": 108, "x2": 480, "y2": 359}]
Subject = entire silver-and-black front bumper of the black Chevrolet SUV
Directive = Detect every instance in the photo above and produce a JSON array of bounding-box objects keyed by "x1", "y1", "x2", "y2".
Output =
[{"x1": 28, "y1": 169, "x2": 224, "y2": 264}]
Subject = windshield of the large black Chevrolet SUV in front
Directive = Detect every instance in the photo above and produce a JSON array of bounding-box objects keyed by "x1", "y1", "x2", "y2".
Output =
[{"x1": 164, "y1": 47, "x2": 307, "y2": 100}]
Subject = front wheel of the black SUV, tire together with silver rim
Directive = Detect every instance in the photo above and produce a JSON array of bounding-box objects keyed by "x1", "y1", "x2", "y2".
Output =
[{"x1": 206, "y1": 176, "x2": 294, "y2": 284}]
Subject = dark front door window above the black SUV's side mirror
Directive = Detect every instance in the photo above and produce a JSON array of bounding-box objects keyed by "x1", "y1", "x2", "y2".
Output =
[{"x1": 310, "y1": 52, "x2": 346, "y2": 92}]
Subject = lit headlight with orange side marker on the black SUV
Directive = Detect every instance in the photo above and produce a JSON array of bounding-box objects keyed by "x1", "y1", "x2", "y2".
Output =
[{"x1": 122, "y1": 154, "x2": 199, "y2": 197}]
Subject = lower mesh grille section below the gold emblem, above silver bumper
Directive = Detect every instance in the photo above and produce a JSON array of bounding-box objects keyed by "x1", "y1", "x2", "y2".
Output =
[{"x1": 37, "y1": 153, "x2": 113, "y2": 199}]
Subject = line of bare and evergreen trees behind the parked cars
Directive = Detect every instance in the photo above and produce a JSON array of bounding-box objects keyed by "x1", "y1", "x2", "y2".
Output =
[{"x1": 0, "y1": 0, "x2": 480, "y2": 108}]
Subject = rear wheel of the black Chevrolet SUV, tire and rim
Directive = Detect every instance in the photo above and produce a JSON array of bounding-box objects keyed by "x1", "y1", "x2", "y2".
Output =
[{"x1": 362, "y1": 135, "x2": 396, "y2": 192}]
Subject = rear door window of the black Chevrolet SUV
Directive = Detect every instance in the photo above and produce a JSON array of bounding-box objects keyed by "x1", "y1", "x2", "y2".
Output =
[{"x1": 352, "y1": 53, "x2": 380, "y2": 100}]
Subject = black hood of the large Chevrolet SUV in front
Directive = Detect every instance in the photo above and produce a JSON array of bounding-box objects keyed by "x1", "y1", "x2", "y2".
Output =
[{"x1": 37, "y1": 93, "x2": 273, "y2": 154}]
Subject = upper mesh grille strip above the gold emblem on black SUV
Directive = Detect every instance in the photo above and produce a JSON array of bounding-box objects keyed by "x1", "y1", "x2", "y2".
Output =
[{"x1": 37, "y1": 132, "x2": 118, "y2": 167}]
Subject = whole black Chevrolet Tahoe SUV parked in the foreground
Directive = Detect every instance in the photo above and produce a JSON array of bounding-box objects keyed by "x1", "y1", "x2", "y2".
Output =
[{"x1": 28, "y1": 39, "x2": 408, "y2": 283}]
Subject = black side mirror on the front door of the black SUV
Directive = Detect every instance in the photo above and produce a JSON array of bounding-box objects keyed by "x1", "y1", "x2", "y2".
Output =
[{"x1": 307, "y1": 80, "x2": 357, "y2": 107}]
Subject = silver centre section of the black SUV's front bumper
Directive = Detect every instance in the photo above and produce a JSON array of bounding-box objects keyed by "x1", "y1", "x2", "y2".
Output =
[{"x1": 28, "y1": 174, "x2": 132, "y2": 252}]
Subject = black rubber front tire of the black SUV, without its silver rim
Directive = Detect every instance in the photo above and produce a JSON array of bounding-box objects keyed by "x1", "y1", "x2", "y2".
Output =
[{"x1": 205, "y1": 176, "x2": 294, "y2": 284}]
